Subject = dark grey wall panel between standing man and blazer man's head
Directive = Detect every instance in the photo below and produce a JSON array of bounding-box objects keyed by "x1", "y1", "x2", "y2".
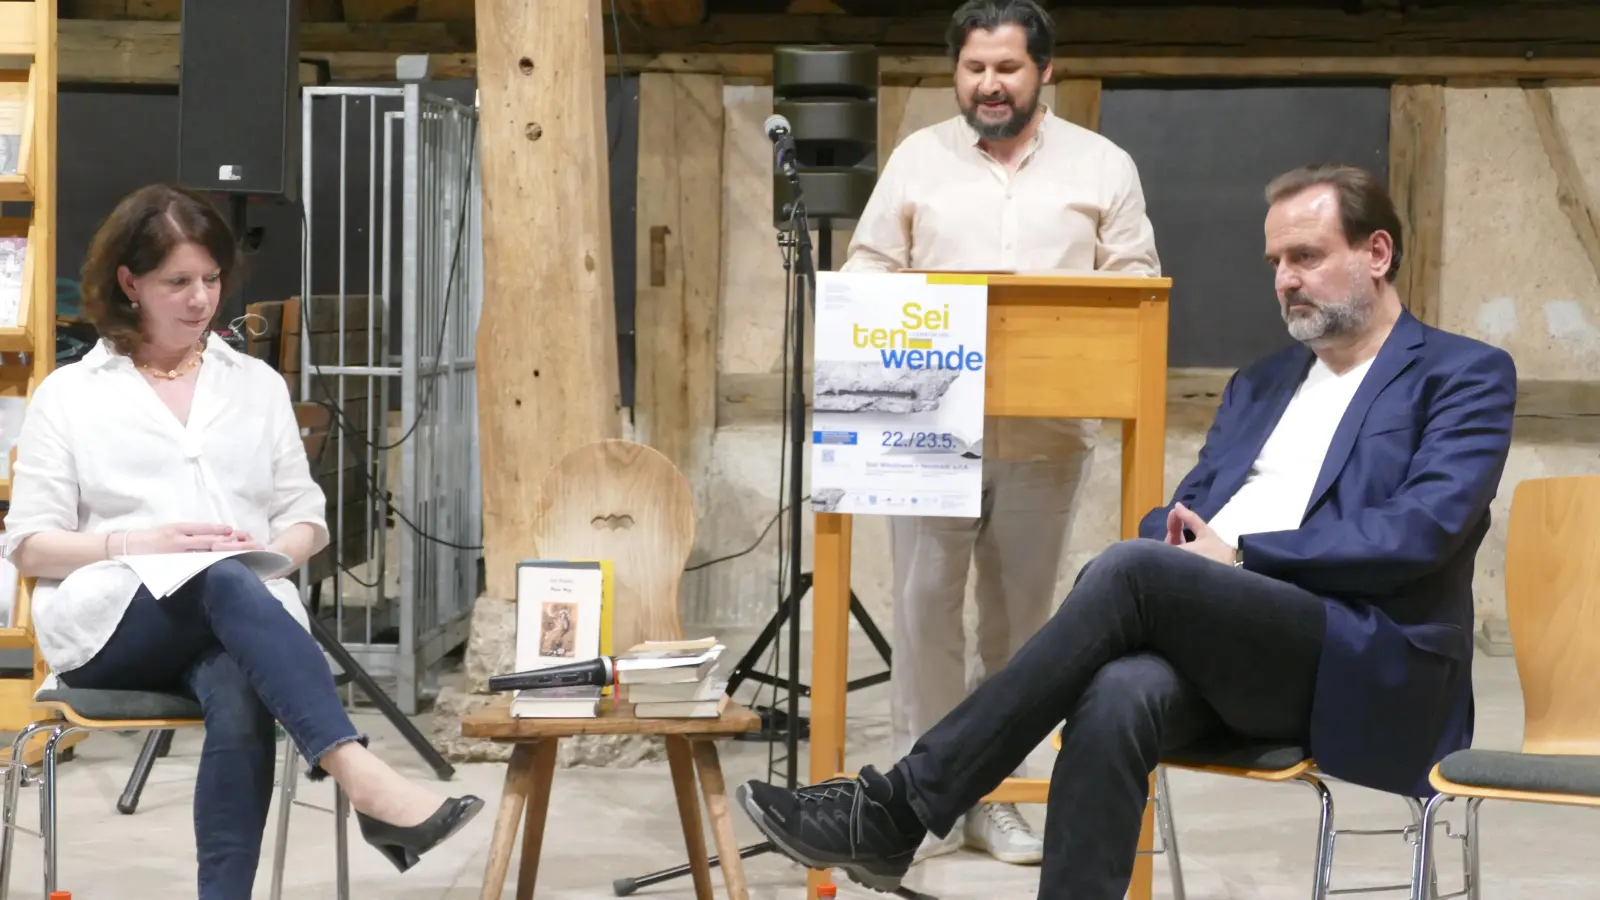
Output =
[{"x1": 1101, "y1": 82, "x2": 1389, "y2": 367}]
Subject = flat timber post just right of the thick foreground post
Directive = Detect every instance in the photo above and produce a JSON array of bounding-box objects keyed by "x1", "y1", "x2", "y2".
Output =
[{"x1": 634, "y1": 72, "x2": 723, "y2": 503}]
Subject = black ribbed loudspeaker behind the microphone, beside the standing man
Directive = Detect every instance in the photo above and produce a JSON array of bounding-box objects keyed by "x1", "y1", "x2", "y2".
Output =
[{"x1": 773, "y1": 45, "x2": 878, "y2": 227}]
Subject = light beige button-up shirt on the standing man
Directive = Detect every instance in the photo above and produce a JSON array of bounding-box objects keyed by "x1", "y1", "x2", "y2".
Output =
[{"x1": 843, "y1": 109, "x2": 1162, "y2": 461}]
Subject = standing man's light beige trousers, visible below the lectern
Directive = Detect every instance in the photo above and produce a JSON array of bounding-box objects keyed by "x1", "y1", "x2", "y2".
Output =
[{"x1": 890, "y1": 448, "x2": 1093, "y2": 775}]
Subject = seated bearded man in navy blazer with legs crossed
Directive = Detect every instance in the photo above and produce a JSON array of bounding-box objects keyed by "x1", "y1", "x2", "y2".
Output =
[{"x1": 739, "y1": 167, "x2": 1517, "y2": 900}]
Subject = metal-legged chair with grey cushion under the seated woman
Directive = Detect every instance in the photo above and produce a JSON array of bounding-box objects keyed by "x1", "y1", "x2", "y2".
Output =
[{"x1": 0, "y1": 580, "x2": 350, "y2": 900}]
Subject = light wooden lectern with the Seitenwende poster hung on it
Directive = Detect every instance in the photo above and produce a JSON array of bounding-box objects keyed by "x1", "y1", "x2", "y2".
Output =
[{"x1": 808, "y1": 272, "x2": 1171, "y2": 900}]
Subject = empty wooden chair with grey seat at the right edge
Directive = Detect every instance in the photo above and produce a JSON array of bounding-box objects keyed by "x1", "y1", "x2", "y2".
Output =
[{"x1": 1413, "y1": 476, "x2": 1600, "y2": 900}]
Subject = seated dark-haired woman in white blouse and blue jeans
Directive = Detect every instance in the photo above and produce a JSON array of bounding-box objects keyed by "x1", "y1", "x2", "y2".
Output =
[{"x1": 3, "y1": 186, "x2": 483, "y2": 900}]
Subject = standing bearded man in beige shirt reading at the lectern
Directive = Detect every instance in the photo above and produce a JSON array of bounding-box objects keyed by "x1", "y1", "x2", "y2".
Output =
[{"x1": 843, "y1": 0, "x2": 1160, "y2": 865}]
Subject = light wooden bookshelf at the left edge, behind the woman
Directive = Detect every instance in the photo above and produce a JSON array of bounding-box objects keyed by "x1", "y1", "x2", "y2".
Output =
[{"x1": 0, "y1": 0, "x2": 67, "y2": 764}]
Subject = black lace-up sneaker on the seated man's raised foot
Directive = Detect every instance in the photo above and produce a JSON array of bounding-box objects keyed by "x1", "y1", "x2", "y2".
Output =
[{"x1": 736, "y1": 765, "x2": 925, "y2": 894}]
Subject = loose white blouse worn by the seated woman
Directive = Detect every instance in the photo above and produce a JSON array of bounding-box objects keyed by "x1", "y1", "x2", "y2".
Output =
[{"x1": 0, "y1": 335, "x2": 328, "y2": 687}]
